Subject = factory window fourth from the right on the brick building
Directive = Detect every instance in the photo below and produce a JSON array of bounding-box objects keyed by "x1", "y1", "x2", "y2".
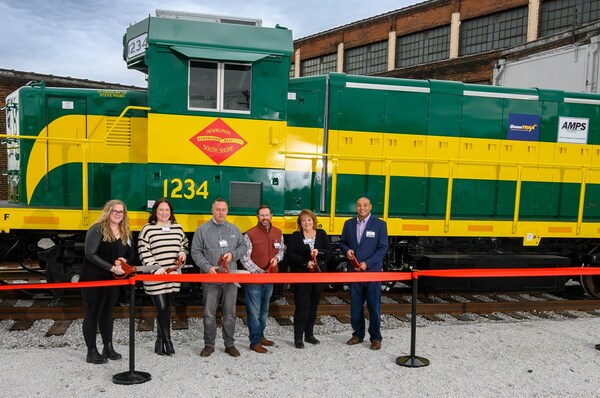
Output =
[{"x1": 344, "y1": 41, "x2": 387, "y2": 75}]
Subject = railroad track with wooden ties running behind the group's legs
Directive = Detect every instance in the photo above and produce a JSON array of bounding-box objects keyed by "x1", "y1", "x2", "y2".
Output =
[{"x1": 0, "y1": 267, "x2": 600, "y2": 335}]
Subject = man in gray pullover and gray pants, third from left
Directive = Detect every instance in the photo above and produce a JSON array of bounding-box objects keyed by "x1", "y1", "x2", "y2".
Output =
[{"x1": 191, "y1": 198, "x2": 247, "y2": 357}]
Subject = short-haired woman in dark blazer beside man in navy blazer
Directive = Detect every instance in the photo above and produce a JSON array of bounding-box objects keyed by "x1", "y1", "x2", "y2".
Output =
[{"x1": 285, "y1": 209, "x2": 333, "y2": 348}]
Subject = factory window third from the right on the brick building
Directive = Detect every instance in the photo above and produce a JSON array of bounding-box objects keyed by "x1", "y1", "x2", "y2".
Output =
[{"x1": 396, "y1": 25, "x2": 450, "y2": 68}]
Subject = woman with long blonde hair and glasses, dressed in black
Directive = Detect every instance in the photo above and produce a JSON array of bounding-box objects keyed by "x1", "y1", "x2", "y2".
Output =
[{"x1": 80, "y1": 200, "x2": 133, "y2": 364}]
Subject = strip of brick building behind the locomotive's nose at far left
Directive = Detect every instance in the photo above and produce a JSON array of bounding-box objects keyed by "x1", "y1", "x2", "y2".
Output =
[{"x1": 0, "y1": 69, "x2": 139, "y2": 200}]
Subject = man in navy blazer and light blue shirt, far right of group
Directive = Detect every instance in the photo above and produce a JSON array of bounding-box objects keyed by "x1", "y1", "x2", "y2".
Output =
[{"x1": 340, "y1": 196, "x2": 388, "y2": 350}]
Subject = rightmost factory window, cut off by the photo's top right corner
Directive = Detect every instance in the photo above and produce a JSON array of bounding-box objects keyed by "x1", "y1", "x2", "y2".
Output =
[{"x1": 540, "y1": 0, "x2": 600, "y2": 37}]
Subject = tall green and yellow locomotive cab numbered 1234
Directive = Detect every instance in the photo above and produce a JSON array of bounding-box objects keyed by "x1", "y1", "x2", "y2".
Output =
[{"x1": 123, "y1": 11, "x2": 292, "y2": 224}]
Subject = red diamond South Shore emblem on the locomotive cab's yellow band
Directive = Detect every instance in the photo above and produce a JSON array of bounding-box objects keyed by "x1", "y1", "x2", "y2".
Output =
[{"x1": 190, "y1": 119, "x2": 247, "y2": 164}]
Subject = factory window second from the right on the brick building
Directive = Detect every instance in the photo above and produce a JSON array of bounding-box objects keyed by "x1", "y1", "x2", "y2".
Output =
[{"x1": 460, "y1": 7, "x2": 527, "y2": 55}]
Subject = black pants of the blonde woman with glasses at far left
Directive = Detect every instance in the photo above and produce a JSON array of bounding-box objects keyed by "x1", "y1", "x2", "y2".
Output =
[{"x1": 82, "y1": 286, "x2": 119, "y2": 349}]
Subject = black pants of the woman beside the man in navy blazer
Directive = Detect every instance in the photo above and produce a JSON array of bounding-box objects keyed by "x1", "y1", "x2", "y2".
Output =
[{"x1": 294, "y1": 283, "x2": 324, "y2": 341}]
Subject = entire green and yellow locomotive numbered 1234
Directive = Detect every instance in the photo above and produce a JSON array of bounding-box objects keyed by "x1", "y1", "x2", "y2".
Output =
[{"x1": 0, "y1": 10, "x2": 600, "y2": 296}]
